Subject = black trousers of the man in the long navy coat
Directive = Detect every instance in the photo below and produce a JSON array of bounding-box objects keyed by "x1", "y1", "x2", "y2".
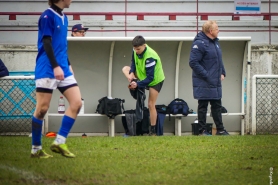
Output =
[{"x1": 198, "y1": 99, "x2": 224, "y2": 133}]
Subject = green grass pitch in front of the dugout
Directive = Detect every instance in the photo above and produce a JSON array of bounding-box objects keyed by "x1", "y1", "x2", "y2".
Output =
[{"x1": 0, "y1": 135, "x2": 278, "y2": 185}]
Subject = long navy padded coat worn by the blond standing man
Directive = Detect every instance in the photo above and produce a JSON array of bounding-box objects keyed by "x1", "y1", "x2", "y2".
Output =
[{"x1": 189, "y1": 32, "x2": 226, "y2": 100}]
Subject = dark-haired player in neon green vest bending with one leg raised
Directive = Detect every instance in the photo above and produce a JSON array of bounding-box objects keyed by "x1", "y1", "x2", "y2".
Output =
[{"x1": 122, "y1": 35, "x2": 165, "y2": 135}]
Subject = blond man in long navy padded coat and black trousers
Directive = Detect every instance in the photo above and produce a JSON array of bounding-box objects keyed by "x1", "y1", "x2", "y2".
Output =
[{"x1": 189, "y1": 21, "x2": 229, "y2": 135}]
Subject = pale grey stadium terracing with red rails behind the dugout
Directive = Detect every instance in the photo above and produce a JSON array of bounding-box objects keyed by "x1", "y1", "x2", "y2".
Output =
[{"x1": 0, "y1": 0, "x2": 278, "y2": 45}]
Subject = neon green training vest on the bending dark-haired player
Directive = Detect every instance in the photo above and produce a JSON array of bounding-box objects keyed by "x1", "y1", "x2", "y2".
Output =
[{"x1": 133, "y1": 44, "x2": 165, "y2": 86}]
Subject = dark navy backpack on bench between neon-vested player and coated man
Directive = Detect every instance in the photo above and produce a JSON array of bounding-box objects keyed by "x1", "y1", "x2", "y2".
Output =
[{"x1": 168, "y1": 98, "x2": 189, "y2": 116}]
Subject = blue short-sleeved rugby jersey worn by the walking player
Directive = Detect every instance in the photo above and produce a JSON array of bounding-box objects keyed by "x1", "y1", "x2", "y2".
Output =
[{"x1": 35, "y1": 8, "x2": 72, "y2": 79}]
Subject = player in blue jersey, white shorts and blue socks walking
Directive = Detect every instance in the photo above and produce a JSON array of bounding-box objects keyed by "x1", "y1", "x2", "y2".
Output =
[{"x1": 31, "y1": 0, "x2": 82, "y2": 158}]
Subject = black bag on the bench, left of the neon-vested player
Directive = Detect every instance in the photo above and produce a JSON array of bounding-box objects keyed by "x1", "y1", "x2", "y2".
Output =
[{"x1": 96, "y1": 96, "x2": 125, "y2": 119}]
